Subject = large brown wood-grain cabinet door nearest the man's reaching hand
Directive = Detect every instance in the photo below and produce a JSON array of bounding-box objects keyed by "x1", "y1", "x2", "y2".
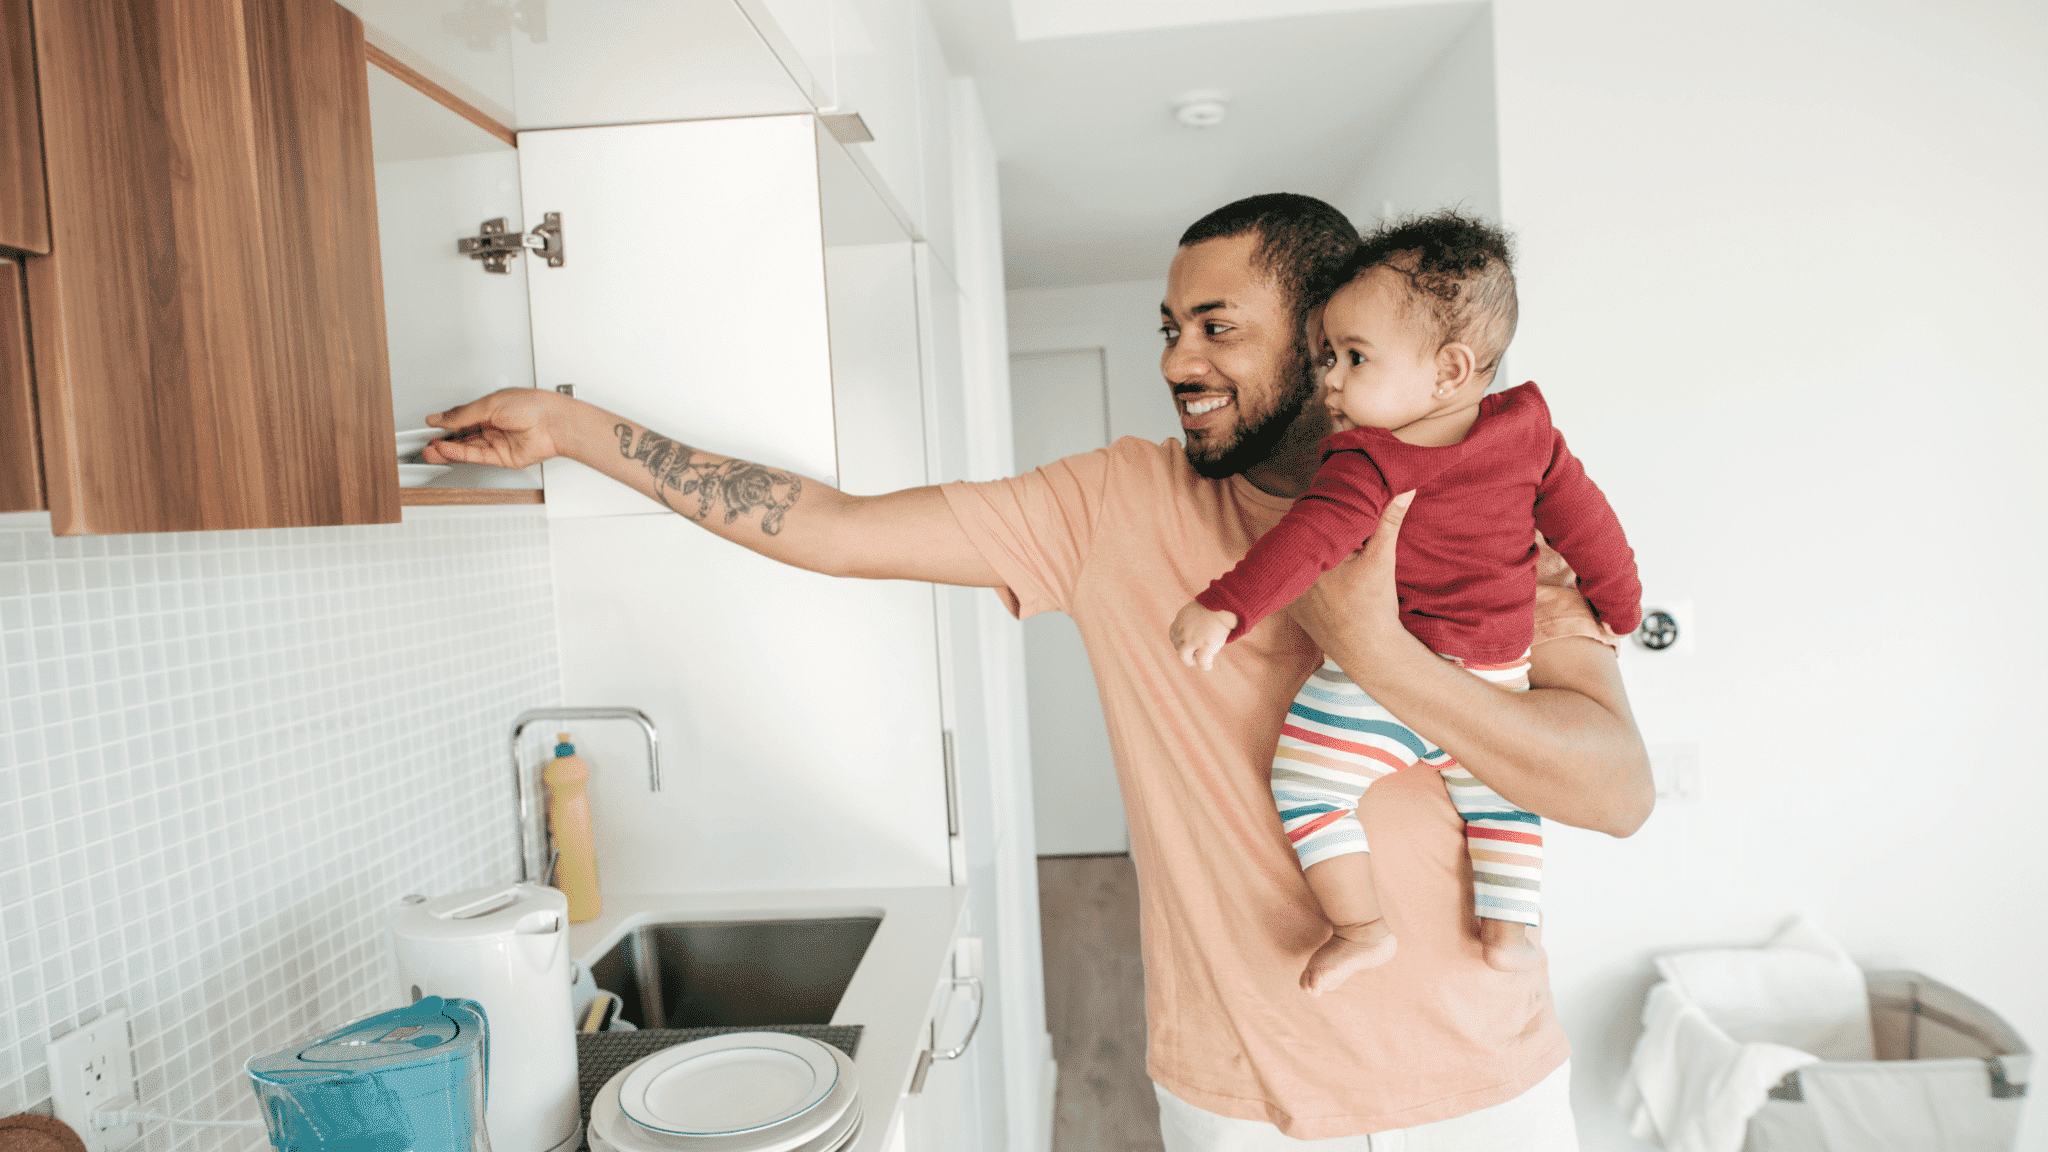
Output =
[{"x1": 22, "y1": 0, "x2": 399, "y2": 535}]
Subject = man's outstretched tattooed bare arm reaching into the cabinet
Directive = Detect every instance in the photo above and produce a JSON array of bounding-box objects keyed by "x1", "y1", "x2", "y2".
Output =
[{"x1": 422, "y1": 387, "x2": 1004, "y2": 588}]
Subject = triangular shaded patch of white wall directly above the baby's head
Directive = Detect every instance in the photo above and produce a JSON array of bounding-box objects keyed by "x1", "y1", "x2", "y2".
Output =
[{"x1": 1331, "y1": 8, "x2": 1501, "y2": 230}]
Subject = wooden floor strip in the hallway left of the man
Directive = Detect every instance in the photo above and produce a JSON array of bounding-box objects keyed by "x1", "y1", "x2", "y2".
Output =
[{"x1": 1038, "y1": 857, "x2": 1163, "y2": 1152}]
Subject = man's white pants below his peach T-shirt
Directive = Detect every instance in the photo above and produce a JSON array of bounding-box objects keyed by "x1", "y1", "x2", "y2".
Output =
[{"x1": 1153, "y1": 1062, "x2": 1579, "y2": 1152}]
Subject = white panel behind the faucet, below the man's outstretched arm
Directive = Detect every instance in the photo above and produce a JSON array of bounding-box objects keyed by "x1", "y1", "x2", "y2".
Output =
[{"x1": 549, "y1": 517, "x2": 950, "y2": 894}]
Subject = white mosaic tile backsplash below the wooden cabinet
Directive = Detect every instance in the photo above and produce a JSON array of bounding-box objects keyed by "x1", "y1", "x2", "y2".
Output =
[{"x1": 0, "y1": 510, "x2": 561, "y2": 1150}]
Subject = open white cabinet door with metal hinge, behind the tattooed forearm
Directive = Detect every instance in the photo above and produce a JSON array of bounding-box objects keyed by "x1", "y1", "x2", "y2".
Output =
[{"x1": 518, "y1": 115, "x2": 838, "y2": 519}]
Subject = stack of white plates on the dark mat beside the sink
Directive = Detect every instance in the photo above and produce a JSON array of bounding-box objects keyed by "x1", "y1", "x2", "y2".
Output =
[{"x1": 590, "y1": 1031, "x2": 860, "y2": 1152}]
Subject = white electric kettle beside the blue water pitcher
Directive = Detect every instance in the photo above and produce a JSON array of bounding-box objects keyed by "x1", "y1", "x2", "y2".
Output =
[{"x1": 391, "y1": 883, "x2": 584, "y2": 1152}]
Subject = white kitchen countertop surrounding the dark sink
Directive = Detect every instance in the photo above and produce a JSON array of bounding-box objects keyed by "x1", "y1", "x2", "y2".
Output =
[{"x1": 569, "y1": 888, "x2": 967, "y2": 1152}]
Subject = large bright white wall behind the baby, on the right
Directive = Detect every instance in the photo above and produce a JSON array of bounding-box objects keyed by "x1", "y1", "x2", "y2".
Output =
[{"x1": 1493, "y1": 0, "x2": 2048, "y2": 1152}]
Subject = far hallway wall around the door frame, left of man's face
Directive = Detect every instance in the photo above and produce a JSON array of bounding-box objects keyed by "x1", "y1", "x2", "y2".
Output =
[{"x1": 1010, "y1": 278, "x2": 1180, "y2": 441}]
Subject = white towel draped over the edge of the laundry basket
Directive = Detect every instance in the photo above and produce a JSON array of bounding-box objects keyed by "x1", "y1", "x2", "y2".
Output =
[{"x1": 1616, "y1": 920, "x2": 1872, "y2": 1152}]
